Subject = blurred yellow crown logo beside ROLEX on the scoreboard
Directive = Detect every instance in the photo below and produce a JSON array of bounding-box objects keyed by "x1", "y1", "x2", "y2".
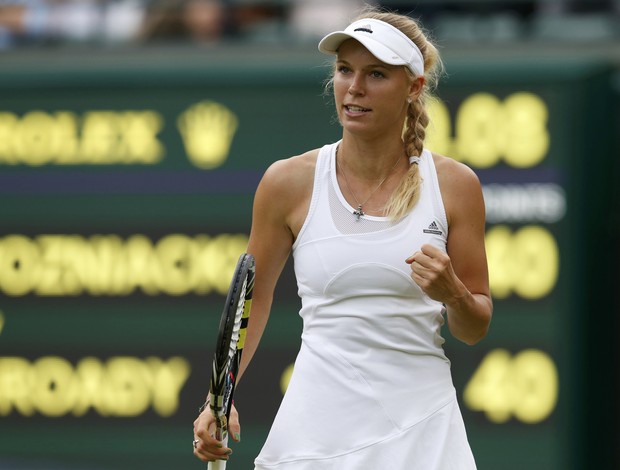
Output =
[{"x1": 177, "y1": 101, "x2": 239, "y2": 169}]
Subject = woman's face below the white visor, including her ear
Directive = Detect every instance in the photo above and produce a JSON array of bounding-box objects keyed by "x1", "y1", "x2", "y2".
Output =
[{"x1": 333, "y1": 39, "x2": 423, "y2": 137}]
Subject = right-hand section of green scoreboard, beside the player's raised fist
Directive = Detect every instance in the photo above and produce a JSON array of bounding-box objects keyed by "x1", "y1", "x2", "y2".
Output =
[{"x1": 428, "y1": 57, "x2": 617, "y2": 469}]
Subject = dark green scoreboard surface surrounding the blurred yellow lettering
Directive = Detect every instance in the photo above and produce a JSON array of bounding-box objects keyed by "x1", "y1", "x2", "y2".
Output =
[{"x1": 0, "y1": 48, "x2": 619, "y2": 470}]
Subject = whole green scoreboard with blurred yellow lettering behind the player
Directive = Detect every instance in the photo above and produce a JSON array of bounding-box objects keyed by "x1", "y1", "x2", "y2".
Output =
[{"x1": 0, "y1": 45, "x2": 618, "y2": 470}]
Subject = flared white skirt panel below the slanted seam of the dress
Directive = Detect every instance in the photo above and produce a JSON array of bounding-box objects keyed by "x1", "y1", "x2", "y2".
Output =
[{"x1": 254, "y1": 399, "x2": 476, "y2": 470}]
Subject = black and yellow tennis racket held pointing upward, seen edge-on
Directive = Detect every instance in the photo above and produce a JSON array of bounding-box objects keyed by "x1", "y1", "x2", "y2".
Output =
[{"x1": 207, "y1": 253, "x2": 255, "y2": 470}]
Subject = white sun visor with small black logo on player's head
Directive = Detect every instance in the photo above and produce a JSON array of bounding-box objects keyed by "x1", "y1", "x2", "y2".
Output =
[{"x1": 319, "y1": 18, "x2": 424, "y2": 75}]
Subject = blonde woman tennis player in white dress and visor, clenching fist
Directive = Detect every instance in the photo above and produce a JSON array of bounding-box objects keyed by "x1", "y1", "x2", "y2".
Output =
[{"x1": 194, "y1": 6, "x2": 492, "y2": 470}]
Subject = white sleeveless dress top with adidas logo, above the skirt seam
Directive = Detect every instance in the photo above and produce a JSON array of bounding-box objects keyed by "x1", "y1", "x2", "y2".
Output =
[{"x1": 257, "y1": 143, "x2": 455, "y2": 468}]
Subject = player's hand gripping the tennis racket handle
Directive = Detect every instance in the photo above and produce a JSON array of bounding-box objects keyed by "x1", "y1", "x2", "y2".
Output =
[{"x1": 194, "y1": 404, "x2": 241, "y2": 462}]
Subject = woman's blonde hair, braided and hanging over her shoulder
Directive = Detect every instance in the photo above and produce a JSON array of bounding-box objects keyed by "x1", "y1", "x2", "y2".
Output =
[{"x1": 326, "y1": 6, "x2": 443, "y2": 220}]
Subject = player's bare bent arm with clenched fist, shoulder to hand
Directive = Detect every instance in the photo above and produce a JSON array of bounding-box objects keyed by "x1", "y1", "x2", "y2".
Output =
[{"x1": 408, "y1": 157, "x2": 493, "y2": 344}]
